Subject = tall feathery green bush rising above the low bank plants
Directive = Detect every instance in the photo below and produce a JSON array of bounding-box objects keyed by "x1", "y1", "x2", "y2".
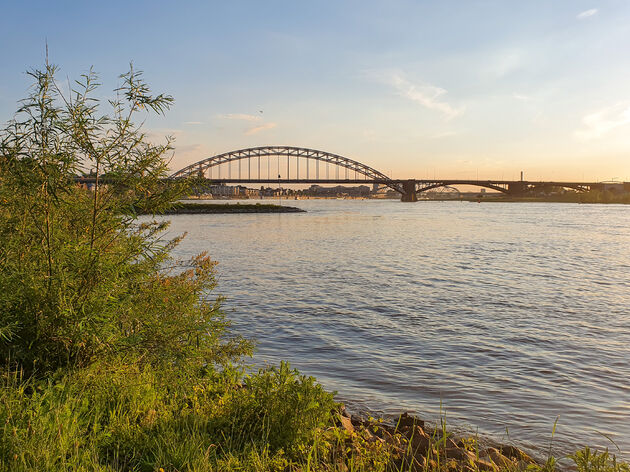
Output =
[{"x1": 0, "y1": 65, "x2": 250, "y2": 376}]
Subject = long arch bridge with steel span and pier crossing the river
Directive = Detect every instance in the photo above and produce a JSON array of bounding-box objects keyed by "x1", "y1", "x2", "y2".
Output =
[{"x1": 169, "y1": 146, "x2": 599, "y2": 202}]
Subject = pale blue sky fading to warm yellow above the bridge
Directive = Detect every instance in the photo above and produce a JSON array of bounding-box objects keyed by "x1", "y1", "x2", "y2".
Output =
[{"x1": 0, "y1": 0, "x2": 630, "y2": 181}]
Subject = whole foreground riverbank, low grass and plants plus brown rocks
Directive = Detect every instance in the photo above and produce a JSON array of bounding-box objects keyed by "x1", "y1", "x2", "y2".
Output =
[{"x1": 0, "y1": 363, "x2": 630, "y2": 472}]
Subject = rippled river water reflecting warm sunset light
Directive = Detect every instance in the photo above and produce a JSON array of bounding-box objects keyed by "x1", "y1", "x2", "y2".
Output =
[{"x1": 165, "y1": 200, "x2": 630, "y2": 459}]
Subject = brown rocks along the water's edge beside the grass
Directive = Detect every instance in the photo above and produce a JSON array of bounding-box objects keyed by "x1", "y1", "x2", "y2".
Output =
[{"x1": 337, "y1": 407, "x2": 542, "y2": 472}]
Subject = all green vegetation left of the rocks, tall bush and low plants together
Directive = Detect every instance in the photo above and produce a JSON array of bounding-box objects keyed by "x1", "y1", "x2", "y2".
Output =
[{"x1": 0, "y1": 60, "x2": 340, "y2": 471}]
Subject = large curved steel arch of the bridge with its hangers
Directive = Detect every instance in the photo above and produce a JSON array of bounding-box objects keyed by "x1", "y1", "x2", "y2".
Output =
[{"x1": 169, "y1": 146, "x2": 403, "y2": 193}]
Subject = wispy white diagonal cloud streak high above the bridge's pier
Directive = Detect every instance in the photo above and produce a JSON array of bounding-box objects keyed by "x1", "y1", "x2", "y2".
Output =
[{"x1": 372, "y1": 72, "x2": 464, "y2": 119}]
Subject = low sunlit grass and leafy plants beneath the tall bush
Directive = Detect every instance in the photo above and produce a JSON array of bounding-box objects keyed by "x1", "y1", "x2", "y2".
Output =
[{"x1": 0, "y1": 363, "x2": 333, "y2": 471}]
